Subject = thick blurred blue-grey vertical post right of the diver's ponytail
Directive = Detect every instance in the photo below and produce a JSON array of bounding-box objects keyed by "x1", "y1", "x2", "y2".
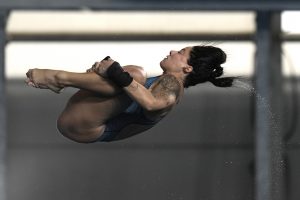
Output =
[{"x1": 255, "y1": 11, "x2": 286, "y2": 200}]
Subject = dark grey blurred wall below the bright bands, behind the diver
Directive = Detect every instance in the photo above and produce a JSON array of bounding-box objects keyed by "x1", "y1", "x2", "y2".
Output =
[{"x1": 7, "y1": 80, "x2": 300, "y2": 200}]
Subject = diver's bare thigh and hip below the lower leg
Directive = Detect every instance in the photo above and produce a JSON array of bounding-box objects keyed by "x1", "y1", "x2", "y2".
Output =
[{"x1": 58, "y1": 90, "x2": 132, "y2": 142}]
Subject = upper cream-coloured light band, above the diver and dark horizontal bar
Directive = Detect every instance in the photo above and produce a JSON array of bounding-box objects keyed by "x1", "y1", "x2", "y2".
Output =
[{"x1": 7, "y1": 10, "x2": 255, "y2": 35}]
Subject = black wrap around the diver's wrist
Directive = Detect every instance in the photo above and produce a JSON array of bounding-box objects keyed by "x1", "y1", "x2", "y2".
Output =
[{"x1": 106, "y1": 62, "x2": 133, "y2": 87}]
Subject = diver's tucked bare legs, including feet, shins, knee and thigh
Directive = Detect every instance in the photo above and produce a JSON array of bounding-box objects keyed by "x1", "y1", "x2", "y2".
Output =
[{"x1": 26, "y1": 66, "x2": 146, "y2": 143}]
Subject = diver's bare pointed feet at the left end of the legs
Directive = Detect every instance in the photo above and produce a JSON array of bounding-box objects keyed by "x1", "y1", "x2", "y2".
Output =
[{"x1": 26, "y1": 69, "x2": 64, "y2": 93}]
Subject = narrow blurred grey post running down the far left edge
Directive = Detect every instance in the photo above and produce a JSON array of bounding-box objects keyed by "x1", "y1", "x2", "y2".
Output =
[{"x1": 0, "y1": 10, "x2": 8, "y2": 200}]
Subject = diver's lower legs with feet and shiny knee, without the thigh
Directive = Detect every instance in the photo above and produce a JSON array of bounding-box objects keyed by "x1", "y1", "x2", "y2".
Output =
[{"x1": 26, "y1": 66, "x2": 146, "y2": 97}]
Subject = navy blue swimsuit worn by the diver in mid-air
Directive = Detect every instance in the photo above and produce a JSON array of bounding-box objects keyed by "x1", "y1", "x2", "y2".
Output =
[{"x1": 98, "y1": 77, "x2": 160, "y2": 142}]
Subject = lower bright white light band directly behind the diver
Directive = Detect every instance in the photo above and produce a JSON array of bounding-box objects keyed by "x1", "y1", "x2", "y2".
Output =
[{"x1": 6, "y1": 41, "x2": 255, "y2": 78}]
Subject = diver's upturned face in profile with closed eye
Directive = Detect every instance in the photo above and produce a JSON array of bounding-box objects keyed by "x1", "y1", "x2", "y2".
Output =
[{"x1": 160, "y1": 47, "x2": 192, "y2": 72}]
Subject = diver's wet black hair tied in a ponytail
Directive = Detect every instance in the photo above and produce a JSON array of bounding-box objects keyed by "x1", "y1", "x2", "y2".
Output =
[{"x1": 184, "y1": 46, "x2": 234, "y2": 88}]
